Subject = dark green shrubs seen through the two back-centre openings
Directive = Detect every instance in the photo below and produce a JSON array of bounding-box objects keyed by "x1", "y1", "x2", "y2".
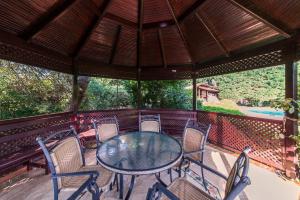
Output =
[{"x1": 80, "y1": 78, "x2": 192, "y2": 110}]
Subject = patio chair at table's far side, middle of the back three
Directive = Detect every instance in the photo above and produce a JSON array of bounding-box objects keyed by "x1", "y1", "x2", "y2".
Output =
[{"x1": 139, "y1": 113, "x2": 161, "y2": 133}]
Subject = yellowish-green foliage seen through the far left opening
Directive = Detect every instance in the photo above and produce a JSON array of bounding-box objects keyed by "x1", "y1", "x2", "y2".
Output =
[{"x1": 0, "y1": 60, "x2": 72, "y2": 119}]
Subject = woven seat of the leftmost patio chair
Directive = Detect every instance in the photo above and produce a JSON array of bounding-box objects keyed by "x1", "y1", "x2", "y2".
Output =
[{"x1": 63, "y1": 165, "x2": 114, "y2": 190}]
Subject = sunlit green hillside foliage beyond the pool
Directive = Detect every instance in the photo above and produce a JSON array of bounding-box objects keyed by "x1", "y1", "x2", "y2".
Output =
[{"x1": 197, "y1": 66, "x2": 285, "y2": 106}]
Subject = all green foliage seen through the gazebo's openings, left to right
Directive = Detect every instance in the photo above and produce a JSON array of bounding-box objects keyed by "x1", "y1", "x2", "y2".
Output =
[{"x1": 0, "y1": 60, "x2": 300, "y2": 119}]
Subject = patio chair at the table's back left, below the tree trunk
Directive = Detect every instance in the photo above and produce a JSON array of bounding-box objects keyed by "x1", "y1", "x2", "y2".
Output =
[{"x1": 92, "y1": 116, "x2": 119, "y2": 149}]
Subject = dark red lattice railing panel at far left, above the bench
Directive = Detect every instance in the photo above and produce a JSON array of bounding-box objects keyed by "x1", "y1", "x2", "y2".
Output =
[{"x1": 0, "y1": 113, "x2": 74, "y2": 157}]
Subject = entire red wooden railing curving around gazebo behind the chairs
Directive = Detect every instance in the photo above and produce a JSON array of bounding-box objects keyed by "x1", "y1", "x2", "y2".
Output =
[{"x1": 0, "y1": 109, "x2": 284, "y2": 175}]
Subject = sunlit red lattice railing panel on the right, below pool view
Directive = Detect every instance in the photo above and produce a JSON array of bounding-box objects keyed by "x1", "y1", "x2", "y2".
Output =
[{"x1": 197, "y1": 111, "x2": 284, "y2": 169}]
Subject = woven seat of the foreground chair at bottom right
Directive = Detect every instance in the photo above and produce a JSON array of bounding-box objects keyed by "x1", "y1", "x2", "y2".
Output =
[{"x1": 161, "y1": 178, "x2": 214, "y2": 200}]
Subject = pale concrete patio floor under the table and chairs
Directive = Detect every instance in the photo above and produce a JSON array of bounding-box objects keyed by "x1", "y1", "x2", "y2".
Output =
[{"x1": 0, "y1": 146, "x2": 300, "y2": 200}]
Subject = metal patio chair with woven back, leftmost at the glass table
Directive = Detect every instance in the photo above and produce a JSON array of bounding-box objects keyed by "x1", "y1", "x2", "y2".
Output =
[{"x1": 36, "y1": 127, "x2": 113, "y2": 200}]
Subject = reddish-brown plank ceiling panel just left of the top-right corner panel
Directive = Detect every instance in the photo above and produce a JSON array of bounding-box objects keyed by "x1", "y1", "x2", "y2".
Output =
[{"x1": 198, "y1": 0, "x2": 279, "y2": 51}]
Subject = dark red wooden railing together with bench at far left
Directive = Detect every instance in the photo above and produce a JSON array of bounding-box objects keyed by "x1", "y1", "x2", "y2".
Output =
[{"x1": 0, "y1": 112, "x2": 75, "y2": 174}]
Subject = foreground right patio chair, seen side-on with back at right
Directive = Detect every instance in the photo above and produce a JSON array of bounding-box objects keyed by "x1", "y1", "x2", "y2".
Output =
[{"x1": 147, "y1": 148, "x2": 250, "y2": 200}]
